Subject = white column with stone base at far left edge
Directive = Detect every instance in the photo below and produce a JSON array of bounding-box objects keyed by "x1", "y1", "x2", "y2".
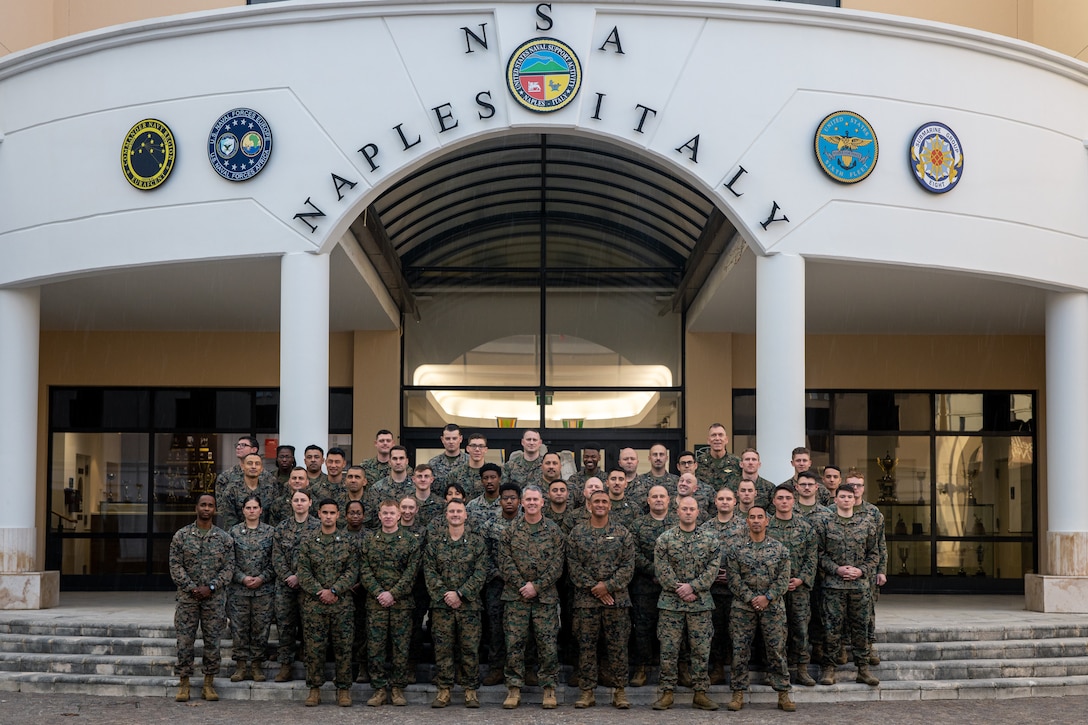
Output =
[{"x1": 0, "y1": 287, "x2": 60, "y2": 610}]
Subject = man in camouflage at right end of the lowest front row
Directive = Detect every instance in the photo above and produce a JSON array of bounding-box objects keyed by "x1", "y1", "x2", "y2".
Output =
[{"x1": 721, "y1": 506, "x2": 790, "y2": 692}]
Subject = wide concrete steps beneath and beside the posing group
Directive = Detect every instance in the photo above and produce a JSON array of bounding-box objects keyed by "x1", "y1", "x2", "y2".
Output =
[{"x1": 0, "y1": 618, "x2": 1088, "y2": 706}]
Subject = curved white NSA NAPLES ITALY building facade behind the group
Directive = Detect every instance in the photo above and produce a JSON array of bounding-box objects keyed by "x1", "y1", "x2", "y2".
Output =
[{"x1": 0, "y1": 0, "x2": 1088, "y2": 610}]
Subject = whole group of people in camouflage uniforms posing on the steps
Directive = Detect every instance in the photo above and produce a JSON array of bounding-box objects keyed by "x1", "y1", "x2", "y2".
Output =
[{"x1": 170, "y1": 423, "x2": 887, "y2": 712}]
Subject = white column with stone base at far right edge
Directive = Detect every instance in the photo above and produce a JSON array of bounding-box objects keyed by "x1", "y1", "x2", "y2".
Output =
[{"x1": 1024, "y1": 292, "x2": 1088, "y2": 612}]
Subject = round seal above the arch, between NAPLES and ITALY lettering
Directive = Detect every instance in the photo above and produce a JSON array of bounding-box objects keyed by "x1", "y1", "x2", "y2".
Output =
[{"x1": 506, "y1": 38, "x2": 582, "y2": 113}]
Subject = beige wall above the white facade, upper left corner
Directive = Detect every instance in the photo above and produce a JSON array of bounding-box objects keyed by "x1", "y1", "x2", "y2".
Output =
[{"x1": 0, "y1": 0, "x2": 246, "y2": 56}]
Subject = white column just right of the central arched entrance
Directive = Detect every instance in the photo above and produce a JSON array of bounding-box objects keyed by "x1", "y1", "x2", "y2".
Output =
[{"x1": 755, "y1": 255, "x2": 805, "y2": 481}]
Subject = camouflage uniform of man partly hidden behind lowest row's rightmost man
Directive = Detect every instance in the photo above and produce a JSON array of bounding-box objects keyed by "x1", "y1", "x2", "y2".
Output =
[{"x1": 767, "y1": 500, "x2": 817, "y2": 671}]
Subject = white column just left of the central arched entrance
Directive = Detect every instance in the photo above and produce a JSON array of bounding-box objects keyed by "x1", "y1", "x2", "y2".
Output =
[{"x1": 280, "y1": 253, "x2": 329, "y2": 452}]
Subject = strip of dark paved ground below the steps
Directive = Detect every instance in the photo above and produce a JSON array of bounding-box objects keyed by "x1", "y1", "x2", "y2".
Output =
[{"x1": 0, "y1": 692, "x2": 1088, "y2": 725}]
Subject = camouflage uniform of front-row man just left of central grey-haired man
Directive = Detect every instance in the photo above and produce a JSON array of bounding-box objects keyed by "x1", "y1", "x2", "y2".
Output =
[{"x1": 423, "y1": 505, "x2": 490, "y2": 690}]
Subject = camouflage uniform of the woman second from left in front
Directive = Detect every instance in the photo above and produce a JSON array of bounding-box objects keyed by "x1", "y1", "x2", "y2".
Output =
[{"x1": 227, "y1": 513, "x2": 275, "y2": 672}]
